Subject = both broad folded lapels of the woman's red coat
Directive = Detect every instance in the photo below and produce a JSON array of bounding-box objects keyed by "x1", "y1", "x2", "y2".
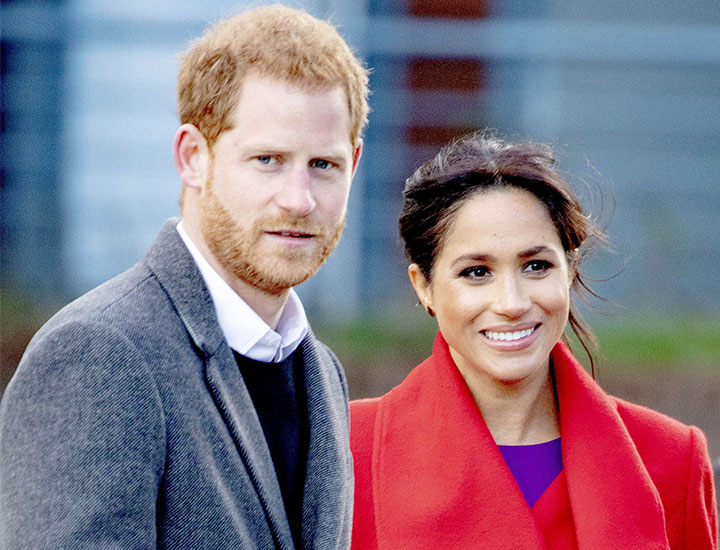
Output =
[{"x1": 373, "y1": 334, "x2": 669, "y2": 550}]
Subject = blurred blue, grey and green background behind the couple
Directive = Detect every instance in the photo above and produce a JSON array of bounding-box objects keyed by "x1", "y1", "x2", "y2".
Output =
[{"x1": 0, "y1": 0, "x2": 720, "y2": 490}]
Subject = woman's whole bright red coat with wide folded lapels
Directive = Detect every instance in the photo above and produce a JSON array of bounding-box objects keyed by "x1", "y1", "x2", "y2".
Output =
[{"x1": 350, "y1": 334, "x2": 718, "y2": 550}]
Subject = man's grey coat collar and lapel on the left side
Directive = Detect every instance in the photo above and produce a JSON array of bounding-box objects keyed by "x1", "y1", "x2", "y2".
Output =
[{"x1": 144, "y1": 219, "x2": 293, "y2": 548}]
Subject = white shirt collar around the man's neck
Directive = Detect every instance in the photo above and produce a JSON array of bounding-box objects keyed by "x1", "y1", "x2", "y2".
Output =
[{"x1": 177, "y1": 221, "x2": 309, "y2": 363}]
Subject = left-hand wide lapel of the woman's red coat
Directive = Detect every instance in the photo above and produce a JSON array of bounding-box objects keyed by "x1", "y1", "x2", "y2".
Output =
[{"x1": 373, "y1": 334, "x2": 546, "y2": 550}]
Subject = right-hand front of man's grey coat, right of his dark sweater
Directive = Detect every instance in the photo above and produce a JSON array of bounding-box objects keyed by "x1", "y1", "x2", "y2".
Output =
[{"x1": 300, "y1": 332, "x2": 353, "y2": 548}]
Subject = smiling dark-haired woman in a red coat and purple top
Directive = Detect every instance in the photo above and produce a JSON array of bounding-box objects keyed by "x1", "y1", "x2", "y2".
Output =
[{"x1": 350, "y1": 134, "x2": 717, "y2": 550}]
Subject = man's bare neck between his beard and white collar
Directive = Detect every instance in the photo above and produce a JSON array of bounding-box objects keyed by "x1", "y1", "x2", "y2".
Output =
[{"x1": 183, "y1": 216, "x2": 290, "y2": 330}]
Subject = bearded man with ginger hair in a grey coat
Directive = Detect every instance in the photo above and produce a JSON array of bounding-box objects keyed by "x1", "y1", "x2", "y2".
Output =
[{"x1": 0, "y1": 6, "x2": 368, "y2": 549}]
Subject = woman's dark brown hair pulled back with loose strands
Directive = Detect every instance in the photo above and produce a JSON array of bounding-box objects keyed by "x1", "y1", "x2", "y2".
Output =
[{"x1": 400, "y1": 132, "x2": 605, "y2": 364}]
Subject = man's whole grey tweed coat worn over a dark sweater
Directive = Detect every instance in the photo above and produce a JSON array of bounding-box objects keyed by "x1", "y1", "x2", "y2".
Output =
[{"x1": 0, "y1": 219, "x2": 353, "y2": 550}]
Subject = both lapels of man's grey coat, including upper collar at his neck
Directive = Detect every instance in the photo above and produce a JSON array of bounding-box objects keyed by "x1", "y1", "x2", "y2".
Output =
[{"x1": 144, "y1": 219, "x2": 352, "y2": 548}]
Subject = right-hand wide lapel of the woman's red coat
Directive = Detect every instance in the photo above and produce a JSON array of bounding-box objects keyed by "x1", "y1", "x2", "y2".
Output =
[{"x1": 552, "y1": 344, "x2": 670, "y2": 550}]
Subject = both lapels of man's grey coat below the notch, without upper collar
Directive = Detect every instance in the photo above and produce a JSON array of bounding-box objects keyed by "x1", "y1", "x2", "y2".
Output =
[{"x1": 206, "y1": 332, "x2": 352, "y2": 548}]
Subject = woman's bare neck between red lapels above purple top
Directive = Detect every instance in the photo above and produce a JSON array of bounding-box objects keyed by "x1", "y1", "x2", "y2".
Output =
[{"x1": 463, "y1": 368, "x2": 560, "y2": 445}]
